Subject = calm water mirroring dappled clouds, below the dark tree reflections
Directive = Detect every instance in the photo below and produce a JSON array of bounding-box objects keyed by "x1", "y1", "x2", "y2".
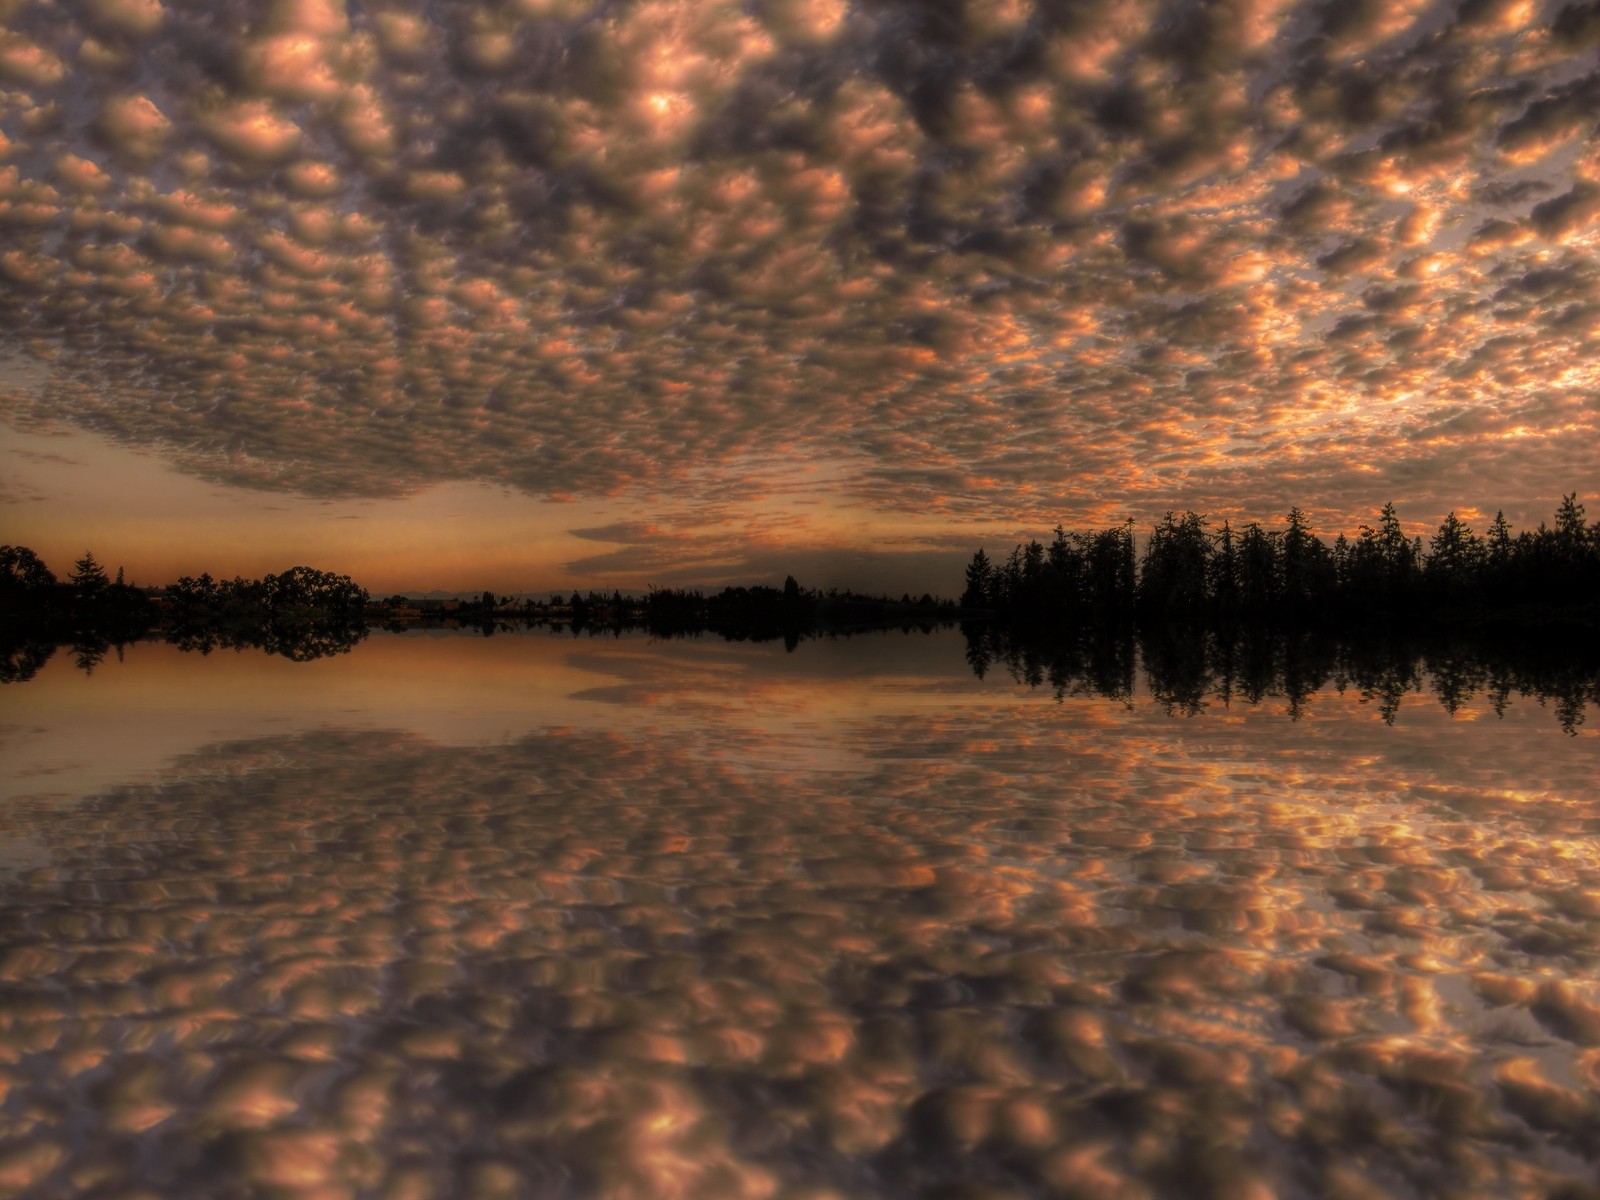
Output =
[{"x1": 0, "y1": 634, "x2": 1600, "y2": 1200}]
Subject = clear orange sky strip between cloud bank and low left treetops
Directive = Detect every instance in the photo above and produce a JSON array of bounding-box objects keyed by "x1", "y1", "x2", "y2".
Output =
[{"x1": 0, "y1": 432, "x2": 965, "y2": 594}]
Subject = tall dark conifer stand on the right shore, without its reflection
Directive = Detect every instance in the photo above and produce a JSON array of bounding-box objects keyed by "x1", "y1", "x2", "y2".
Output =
[{"x1": 962, "y1": 493, "x2": 1600, "y2": 624}]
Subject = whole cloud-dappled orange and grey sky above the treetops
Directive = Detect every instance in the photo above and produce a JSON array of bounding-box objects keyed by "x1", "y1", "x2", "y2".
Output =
[{"x1": 0, "y1": 0, "x2": 1600, "y2": 595}]
